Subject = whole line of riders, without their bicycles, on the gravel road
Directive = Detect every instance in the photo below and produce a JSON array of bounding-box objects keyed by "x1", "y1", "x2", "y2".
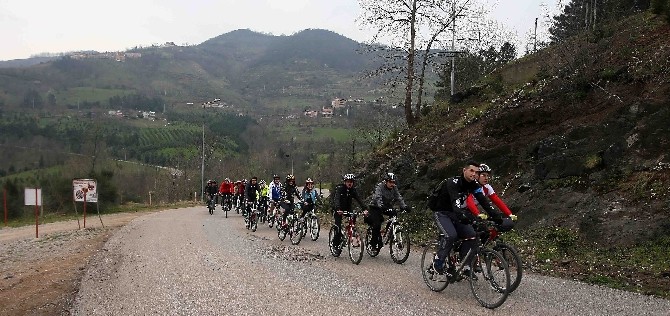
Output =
[{"x1": 206, "y1": 162, "x2": 517, "y2": 266}]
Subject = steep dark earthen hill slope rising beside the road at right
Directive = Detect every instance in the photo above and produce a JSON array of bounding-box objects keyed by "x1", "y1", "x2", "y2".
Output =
[{"x1": 354, "y1": 14, "x2": 670, "y2": 296}]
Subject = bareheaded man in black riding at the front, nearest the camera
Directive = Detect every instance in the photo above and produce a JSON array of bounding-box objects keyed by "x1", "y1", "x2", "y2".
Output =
[{"x1": 433, "y1": 162, "x2": 502, "y2": 275}]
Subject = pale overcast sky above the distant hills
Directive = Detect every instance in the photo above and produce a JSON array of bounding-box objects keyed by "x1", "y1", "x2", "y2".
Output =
[{"x1": 0, "y1": 0, "x2": 565, "y2": 60}]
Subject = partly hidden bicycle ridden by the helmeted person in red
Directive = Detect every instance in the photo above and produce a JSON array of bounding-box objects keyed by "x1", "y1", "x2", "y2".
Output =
[{"x1": 481, "y1": 221, "x2": 523, "y2": 293}]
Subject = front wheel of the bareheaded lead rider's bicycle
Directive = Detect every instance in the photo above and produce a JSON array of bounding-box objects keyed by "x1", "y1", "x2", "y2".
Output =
[{"x1": 466, "y1": 248, "x2": 510, "y2": 309}]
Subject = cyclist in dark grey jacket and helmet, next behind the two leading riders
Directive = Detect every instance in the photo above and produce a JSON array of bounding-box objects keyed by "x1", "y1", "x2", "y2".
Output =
[{"x1": 365, "y1": 172, "x2": 409, "y2": 249}]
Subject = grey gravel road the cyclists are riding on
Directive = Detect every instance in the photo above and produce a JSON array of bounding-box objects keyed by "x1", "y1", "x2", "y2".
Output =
[{"x1": 71, "y1": 207, "x2": 670, "y2": 315}]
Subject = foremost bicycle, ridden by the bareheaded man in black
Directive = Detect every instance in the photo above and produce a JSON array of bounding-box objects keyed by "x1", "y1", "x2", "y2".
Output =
[{"x1": 421, "y1": 220, "x2": 511, "y2": 309}]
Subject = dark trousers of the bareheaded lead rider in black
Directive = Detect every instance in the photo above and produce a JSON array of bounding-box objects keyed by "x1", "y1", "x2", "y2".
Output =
[{"x1": 434, "y1": 212, "x2": 477, "y2": 262}]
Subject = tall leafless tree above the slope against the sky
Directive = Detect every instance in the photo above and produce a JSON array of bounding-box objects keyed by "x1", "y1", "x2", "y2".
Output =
[{"x1": 358, "y1": 0, "x2": 473, "y2": 126}]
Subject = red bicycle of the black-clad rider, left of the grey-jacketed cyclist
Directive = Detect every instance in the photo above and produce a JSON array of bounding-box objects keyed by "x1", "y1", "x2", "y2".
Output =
[{"x1": 328, "y1": 212, "x2": 365, "y2": 264}]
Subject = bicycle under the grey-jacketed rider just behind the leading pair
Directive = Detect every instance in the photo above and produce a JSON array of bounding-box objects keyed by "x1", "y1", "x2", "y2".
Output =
[{"x1": 365, "y1": 209, "x2": 410, "y2": 264}]
